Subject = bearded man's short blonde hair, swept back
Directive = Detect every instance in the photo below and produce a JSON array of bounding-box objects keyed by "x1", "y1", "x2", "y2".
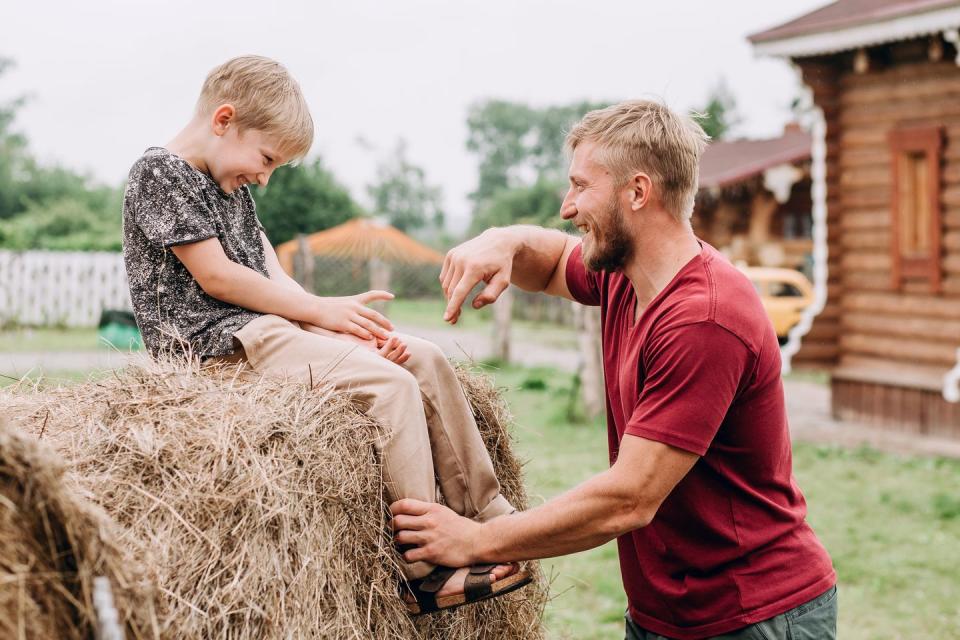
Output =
[{"x1": 567, "y1": 100, "x2": 710, "y2": 221}]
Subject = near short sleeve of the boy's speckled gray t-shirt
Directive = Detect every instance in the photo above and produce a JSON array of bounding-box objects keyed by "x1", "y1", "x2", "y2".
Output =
[{"x1": 131, "y1": 157, "x2": 217, "y2": 247}]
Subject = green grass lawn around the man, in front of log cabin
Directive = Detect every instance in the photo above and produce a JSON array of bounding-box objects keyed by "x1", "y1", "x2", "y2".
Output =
[{"x1": 493, "y1": 368, "x2": 960, "y2": 640}]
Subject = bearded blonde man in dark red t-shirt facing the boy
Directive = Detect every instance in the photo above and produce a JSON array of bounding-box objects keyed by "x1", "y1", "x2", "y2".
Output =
[{"x1": 391, "y1": 101, "x2": 836, "y2": 640}]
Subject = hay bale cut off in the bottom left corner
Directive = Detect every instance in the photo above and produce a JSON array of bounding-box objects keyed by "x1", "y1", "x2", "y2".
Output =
[{"x1": 0, "y1": 421, "x2": 153, "y2": 639}]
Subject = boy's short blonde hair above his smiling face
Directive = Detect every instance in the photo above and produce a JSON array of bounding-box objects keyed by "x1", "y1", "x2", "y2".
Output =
[{"x1": 197, "y1": 56, "x2": 313, "y2": 161}]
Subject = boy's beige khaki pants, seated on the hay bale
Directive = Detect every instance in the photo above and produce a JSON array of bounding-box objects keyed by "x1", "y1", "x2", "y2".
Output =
[{"x1": 227, "y1": 315, "x2": 514, "y2": 580}]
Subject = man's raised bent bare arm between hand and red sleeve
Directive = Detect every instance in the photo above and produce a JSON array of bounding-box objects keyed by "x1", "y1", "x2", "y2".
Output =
[{"x1": 486, "y1": 225, "x2": 569, "y2": 291}]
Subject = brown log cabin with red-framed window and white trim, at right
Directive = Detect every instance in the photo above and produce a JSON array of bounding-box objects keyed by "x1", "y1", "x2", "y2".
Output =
[{"x1": 749, "y1": 0, "x2": 960, "y2": 438}]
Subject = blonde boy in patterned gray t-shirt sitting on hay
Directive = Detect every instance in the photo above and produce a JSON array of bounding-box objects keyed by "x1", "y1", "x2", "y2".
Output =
[{"x1": 123, "y1": 56, "x2": 529, "y2": 613}]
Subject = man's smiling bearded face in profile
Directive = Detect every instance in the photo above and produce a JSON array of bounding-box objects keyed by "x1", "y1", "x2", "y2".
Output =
[{"x1": 560, "y1": 142, "x2": 633, "y2": 271}]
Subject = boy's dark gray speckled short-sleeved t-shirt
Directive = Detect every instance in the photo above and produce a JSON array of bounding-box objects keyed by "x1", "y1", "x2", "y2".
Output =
[{"x1": 123, "y1": 147, "x2": 269, "y2": 358}]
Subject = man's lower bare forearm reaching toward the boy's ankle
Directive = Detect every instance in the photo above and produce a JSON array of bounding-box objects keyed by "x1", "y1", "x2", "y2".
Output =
[{"x1": 474, "y1": 469, "x2": 656, "y2": 562}]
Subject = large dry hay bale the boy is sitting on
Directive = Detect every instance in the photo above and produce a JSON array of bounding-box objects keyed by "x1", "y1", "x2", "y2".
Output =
[{"x1": 0, "y1": 362, "x2": 546, "y2": 640}]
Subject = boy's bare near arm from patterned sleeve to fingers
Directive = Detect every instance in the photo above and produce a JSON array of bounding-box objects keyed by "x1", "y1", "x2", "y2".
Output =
[{"x1": 170, "y1": 238, "x2": 393, "y2": 340}]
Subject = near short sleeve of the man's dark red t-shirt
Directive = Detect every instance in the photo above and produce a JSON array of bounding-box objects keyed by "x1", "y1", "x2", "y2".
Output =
[{"x1": 624, "y1": 321, "x2": 756, "y2": 456}]
